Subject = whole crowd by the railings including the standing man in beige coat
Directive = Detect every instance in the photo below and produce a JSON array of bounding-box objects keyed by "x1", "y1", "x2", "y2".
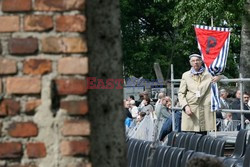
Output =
[{"x1": 124, "y1": 54, "x2": 250, "y2": 141}]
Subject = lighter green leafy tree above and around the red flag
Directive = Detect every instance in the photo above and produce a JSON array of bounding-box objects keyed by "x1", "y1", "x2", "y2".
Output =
[{"x1": 173, "y1": 0, "x2": 244, "y2": 78}]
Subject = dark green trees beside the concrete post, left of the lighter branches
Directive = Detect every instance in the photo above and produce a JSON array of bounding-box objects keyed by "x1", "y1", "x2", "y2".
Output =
[{"x1": 121, "y1": 0, "x2": 174, "y2": 79}]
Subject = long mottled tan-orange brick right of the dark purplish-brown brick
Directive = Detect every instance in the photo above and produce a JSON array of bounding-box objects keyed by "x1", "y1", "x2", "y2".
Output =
[{"x1": 42, "y1": 37, "x2": 87, "y2": 53}]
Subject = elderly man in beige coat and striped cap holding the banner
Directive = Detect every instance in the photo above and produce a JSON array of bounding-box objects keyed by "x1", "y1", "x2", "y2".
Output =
[{"x1": 178, "y1": 54, "x2": 221, "y2": 134}]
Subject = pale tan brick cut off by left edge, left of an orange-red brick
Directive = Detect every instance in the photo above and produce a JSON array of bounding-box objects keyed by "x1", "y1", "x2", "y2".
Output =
[{"x1": 0, "y1": 58, "x2": 17, "y2": 74}]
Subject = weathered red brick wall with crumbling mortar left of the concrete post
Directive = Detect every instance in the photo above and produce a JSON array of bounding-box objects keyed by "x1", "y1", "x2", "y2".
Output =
[{"x1": 0, "y1": 0, "x2": 90, "y2": 167}]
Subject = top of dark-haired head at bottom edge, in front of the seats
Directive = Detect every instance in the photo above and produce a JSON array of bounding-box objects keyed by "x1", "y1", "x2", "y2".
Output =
[{"x1": 186, "y1": 156, "x2": 223, "y2": 167}]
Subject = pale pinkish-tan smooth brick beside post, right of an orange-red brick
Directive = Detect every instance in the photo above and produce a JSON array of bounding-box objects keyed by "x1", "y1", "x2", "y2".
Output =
[{"x1": 58, "y1": 57, "x2": 88, "y2": 75}]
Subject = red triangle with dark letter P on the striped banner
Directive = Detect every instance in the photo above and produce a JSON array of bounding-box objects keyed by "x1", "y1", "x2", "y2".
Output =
[{"x1": 195, "y1": 27, "x2": 229, "y2": 67}]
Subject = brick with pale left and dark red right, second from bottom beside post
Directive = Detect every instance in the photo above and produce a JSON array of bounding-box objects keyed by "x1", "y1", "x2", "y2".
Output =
[{"x1": 60, "y1": 139, "x2": 90, "y2": 156}]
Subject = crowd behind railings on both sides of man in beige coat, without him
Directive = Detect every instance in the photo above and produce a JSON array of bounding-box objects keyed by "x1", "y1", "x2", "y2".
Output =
[{"x1": 124, "y1": 88, "x2": 250, "y2": 141}]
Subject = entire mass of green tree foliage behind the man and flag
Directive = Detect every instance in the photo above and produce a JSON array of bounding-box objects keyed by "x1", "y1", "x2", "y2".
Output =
[{"x1": 121, "y1": 0, "x2": 244, "y2": 79}]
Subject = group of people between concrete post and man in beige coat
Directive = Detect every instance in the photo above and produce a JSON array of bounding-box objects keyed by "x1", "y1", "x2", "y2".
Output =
[{"x1": 124, "y1": 91, "x2": 181, "y2": 141}]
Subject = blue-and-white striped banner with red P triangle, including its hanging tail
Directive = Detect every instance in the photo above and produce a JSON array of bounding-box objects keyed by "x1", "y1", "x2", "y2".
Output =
[{"x1": 195, "y1": 25, "x2": 231, "y2": 111}]
